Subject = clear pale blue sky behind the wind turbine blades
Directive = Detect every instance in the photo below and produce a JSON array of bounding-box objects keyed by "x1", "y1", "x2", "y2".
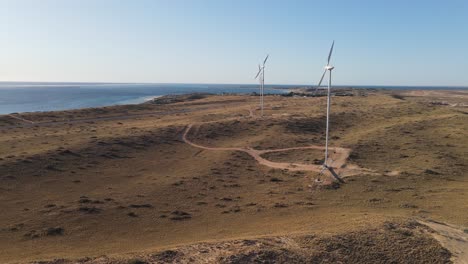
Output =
[{"x1": 0, "y1": 0, "x2": 468, "y2": 86}]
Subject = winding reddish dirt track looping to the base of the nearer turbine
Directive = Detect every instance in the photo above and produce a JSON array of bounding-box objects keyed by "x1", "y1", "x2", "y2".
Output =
[{"x1": 182, "y1": 124, "x2": 364, "y2": 177}]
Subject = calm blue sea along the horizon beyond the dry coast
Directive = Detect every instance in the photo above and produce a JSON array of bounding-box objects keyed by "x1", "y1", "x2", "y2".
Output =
[{"x1": 0, "y1": 82, "x2": 467, "y2": 114}]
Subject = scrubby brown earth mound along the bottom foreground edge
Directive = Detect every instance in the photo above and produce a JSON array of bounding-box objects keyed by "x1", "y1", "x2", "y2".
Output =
[{"x1": 30, "y1": 221, "x2": 451, "y2": 264}]
